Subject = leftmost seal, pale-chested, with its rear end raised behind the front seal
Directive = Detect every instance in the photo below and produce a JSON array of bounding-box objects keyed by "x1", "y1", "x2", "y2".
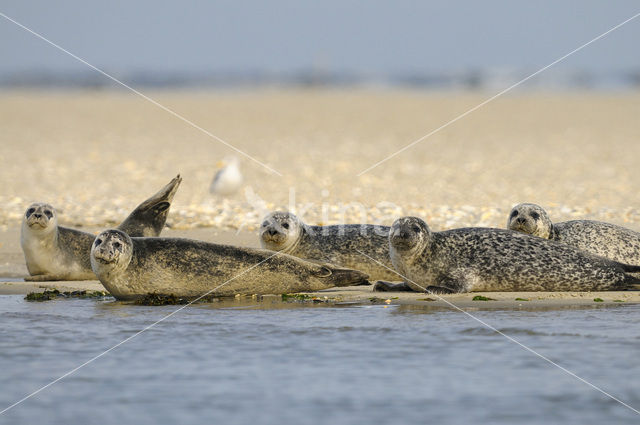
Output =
[{"x1": 20, "y1": 175, "x2": 182, "y2": 281}]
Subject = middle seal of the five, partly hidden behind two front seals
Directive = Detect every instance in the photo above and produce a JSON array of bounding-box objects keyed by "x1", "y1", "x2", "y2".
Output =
[{"x1": 260, "y1": 211, "x2": 398, "y2": 280}]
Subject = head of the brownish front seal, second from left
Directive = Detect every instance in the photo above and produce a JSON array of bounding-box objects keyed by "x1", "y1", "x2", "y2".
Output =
[{"x1": 91, "y1": 229, "x2": 133, "y2": 274}]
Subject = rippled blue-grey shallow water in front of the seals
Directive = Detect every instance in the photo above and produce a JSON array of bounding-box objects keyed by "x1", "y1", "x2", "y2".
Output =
[{"x1": 0, "y1": 296, "x2": 640, "y2": 424}]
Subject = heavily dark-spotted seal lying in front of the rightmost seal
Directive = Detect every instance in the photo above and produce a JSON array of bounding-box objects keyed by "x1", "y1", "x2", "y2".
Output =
[{"x1": 376, "y1": 217, "x2": 640, "y2": 293}]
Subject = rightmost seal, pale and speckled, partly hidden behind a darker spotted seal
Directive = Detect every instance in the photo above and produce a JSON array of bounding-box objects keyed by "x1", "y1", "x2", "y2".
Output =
[{"x1": 507, "y1": 204, "x2": 640, "y2": 265}]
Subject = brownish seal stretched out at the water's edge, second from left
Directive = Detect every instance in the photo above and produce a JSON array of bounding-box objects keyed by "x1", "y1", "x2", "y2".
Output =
[{"x1": 91, "y1": 229, "x2": 367, "y2": 300}]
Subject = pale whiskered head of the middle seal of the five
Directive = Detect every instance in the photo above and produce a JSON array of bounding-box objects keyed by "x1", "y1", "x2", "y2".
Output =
[{"x1": 260, "y1": 211, "x2": 304, "y2": 252}]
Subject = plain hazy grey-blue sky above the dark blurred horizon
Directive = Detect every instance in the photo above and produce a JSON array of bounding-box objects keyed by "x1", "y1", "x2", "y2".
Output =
[{"x1": 0, "y1": 0, "x2": 640, "y2": 76}]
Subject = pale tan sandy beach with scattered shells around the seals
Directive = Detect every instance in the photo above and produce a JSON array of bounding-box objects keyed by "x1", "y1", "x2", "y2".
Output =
[{"x1": 0, "y1": 90, "x2": 640, "y2": 307}]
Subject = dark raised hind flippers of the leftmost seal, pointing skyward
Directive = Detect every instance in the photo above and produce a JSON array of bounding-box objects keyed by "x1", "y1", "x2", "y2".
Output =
[{"x1": 118, "y1": 174, "x2": 182, "y2": 237}]
